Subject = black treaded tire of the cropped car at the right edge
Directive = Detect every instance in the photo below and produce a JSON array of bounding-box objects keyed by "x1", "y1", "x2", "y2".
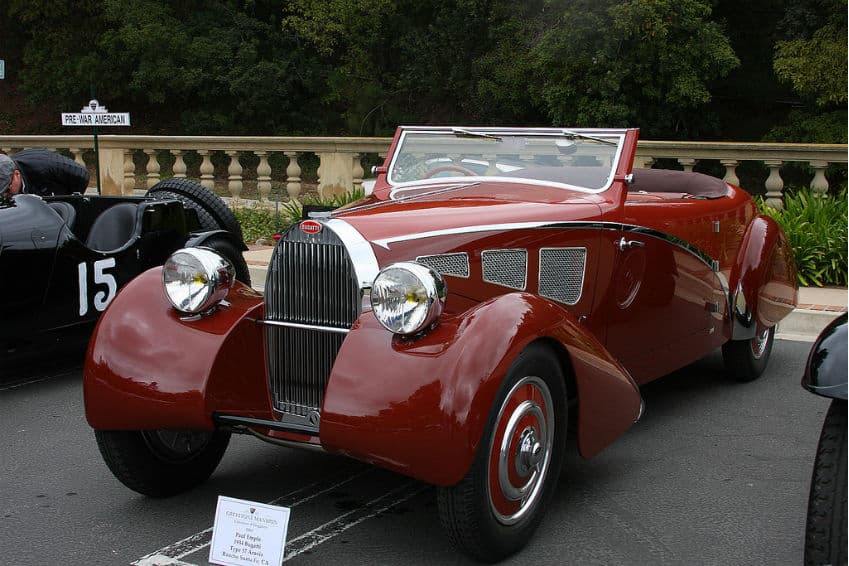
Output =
[{"x1": 805, "y1": 399, "x2": 847, "y2": 566}]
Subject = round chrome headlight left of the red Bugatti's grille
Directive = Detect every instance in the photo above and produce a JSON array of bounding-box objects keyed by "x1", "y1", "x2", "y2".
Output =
[{"x1": 162, "y1": 248, "x2": 236, "y2": 314}]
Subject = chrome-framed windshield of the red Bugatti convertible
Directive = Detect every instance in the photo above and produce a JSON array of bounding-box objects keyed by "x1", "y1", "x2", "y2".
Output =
[{"x1": 388, "y1": 128, "x2": 625, "y2": 192}]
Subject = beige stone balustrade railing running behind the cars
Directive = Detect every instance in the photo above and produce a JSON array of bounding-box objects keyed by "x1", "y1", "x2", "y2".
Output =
[{"x1": 0, "y1": 135, "x2": 847, "y2": 207}]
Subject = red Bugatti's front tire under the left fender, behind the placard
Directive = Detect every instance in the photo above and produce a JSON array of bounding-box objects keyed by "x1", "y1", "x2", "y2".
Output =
[{"x1": 94, "y1": 430, "x2": 230, "y2": 497}]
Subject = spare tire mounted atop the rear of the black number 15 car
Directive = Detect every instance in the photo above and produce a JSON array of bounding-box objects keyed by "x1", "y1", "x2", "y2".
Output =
[{"x1": 146, "y1": 177, "x2": 244, "y2": 242}]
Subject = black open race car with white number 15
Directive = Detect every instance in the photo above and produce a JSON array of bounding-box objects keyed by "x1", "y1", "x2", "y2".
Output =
[{"x1": 0, "y1": 178, "x2": 250, "y2": 369}]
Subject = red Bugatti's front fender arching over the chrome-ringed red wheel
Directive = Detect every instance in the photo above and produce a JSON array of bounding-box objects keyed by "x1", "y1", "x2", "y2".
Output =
[{"x1": 321, "y1": 293, "x2": 641, "y2": 485}]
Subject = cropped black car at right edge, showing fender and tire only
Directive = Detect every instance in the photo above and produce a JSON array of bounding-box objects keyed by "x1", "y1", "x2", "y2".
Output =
[{"x1": 802, "y1": 314, "x2": 847, "y2": 566}]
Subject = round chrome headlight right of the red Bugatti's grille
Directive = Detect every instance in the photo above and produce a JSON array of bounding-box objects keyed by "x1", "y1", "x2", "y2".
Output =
[{"x1": 371, "y1": 262, "x2": 446, "y2": 334}]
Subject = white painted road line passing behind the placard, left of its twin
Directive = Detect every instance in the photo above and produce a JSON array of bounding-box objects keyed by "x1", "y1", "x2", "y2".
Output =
[{"x1": 131, "y1": 467, "x2": 385, "y2": 566}]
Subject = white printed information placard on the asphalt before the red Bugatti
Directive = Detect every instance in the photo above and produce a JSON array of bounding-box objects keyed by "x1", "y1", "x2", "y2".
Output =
[{"x1": 209, "y1": 495, "x2": 289, "y2": 566}]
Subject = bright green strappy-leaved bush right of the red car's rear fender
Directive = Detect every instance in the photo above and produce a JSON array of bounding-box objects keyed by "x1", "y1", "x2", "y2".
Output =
[{"x1": 757, "y1": 189, "x2": 849, "y2": 287}]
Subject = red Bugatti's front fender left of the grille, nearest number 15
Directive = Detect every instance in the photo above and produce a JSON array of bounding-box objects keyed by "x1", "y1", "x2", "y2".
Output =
[{"x1": 83, "y1": 267, "x2": 271, "y2": 430}]
